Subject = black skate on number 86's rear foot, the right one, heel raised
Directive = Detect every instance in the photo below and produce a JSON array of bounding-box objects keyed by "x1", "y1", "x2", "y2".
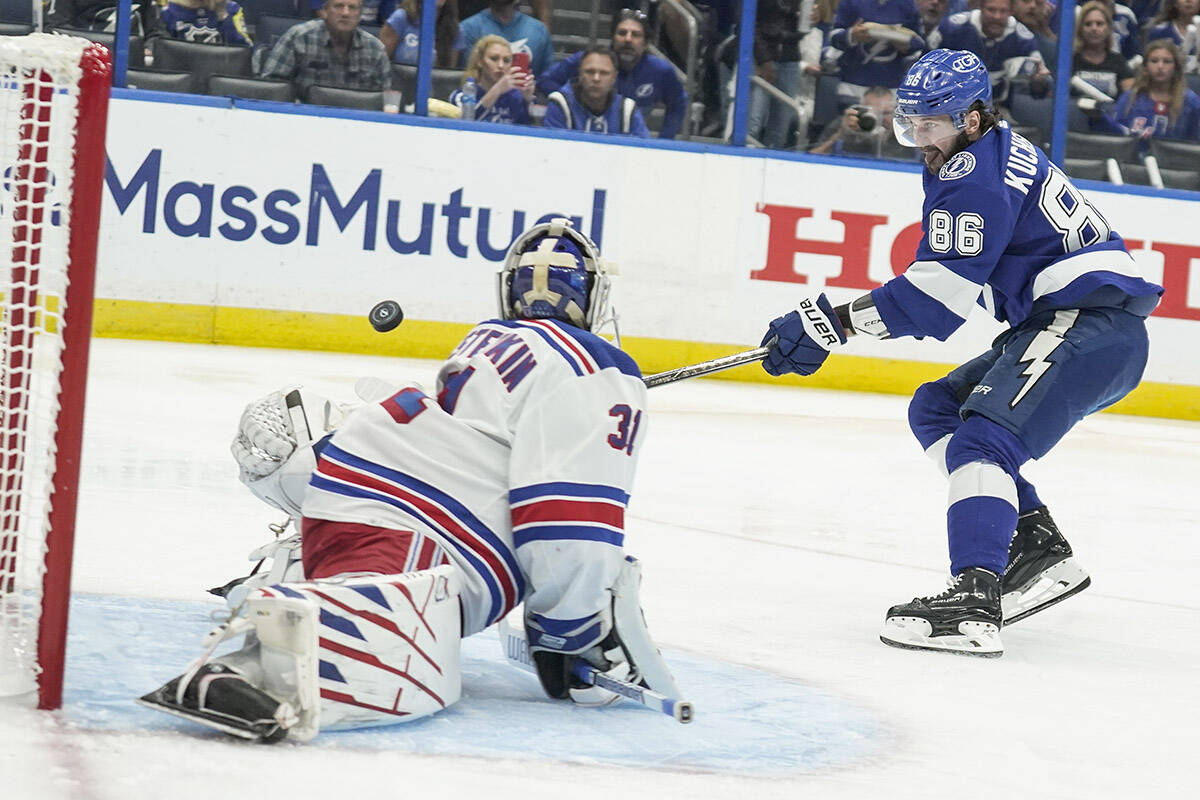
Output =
[{"x1": 1001, "y1": 506, "x2": 1092, "y2": 625}]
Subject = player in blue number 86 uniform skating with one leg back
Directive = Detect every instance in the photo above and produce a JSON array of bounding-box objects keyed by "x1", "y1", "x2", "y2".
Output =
[{"x1": 763, "y1": 49, "x2": 1163, "y2": 656}]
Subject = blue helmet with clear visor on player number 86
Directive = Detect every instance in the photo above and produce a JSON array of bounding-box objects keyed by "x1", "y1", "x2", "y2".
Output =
[{"x1": 893, "y1": 48, "x2": 991, "y2": 148}]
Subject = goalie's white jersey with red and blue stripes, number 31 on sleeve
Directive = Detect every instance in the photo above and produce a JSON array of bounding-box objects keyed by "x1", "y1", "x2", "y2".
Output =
[{"x1": 302, "y1": 320, "x2": 646, "y2": 638}]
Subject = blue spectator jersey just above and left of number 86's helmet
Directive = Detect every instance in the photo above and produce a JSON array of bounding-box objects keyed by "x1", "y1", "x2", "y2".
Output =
[{"x1": 829, "y1": 0, "x2": 925, "y2": 89}]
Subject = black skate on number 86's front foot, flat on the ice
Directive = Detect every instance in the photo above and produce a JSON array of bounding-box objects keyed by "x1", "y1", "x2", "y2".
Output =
[{"x1": 880, "y1": 566, "x2": 1004, "y2": 658}]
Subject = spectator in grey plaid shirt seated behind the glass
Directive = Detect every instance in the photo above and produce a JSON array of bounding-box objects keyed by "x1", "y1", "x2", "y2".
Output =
[{"x1": 262, "y1": 0, "x2": 391, "y2": 97}]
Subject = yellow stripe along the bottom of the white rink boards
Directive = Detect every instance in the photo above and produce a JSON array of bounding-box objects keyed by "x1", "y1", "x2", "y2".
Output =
[{"x1": 94, "y1": 300, "x2": 1200, "y2": 420}]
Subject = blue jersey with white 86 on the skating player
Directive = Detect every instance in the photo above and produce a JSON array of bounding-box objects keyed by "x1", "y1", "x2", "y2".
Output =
[{"x1": 871, "y1": 122, "x2": 1163, "y2": 339}]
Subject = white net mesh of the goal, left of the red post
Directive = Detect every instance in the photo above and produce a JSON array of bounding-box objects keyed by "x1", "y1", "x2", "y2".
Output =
[{"x1": 0, "y1": 34, "x2": 86, "y2": 694}]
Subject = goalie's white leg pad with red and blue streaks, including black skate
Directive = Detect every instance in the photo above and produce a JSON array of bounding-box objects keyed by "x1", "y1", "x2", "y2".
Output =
[{"x1": 138, "y1": 565, "x2": 462, "y2": 742}]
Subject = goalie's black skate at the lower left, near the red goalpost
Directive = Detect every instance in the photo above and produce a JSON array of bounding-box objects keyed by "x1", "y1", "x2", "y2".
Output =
[{"x1": 138, "y1": 663, "x2": 298, "y2": 742}]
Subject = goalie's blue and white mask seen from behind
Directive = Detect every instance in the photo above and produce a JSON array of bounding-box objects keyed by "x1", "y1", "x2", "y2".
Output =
[{"x1": 499, "y1": 218, "x2": 617, "y2": 332}]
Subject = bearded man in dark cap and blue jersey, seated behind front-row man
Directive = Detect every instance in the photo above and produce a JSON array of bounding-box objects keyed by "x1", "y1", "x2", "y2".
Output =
[{"x1": 538, "y1": 8, "x2": 688, "y2": 139}]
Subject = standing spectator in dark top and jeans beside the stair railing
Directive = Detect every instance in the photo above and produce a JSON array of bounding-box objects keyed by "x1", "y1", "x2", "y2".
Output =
[{"x1": 746, "y1": 0, "x2": 811, "y2": 150}]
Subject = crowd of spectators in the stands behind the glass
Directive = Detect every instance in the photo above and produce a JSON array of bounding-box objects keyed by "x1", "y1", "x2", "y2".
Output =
[{"x1": 9, "y1": 0, "x2": 1200, "y2": 176}]
